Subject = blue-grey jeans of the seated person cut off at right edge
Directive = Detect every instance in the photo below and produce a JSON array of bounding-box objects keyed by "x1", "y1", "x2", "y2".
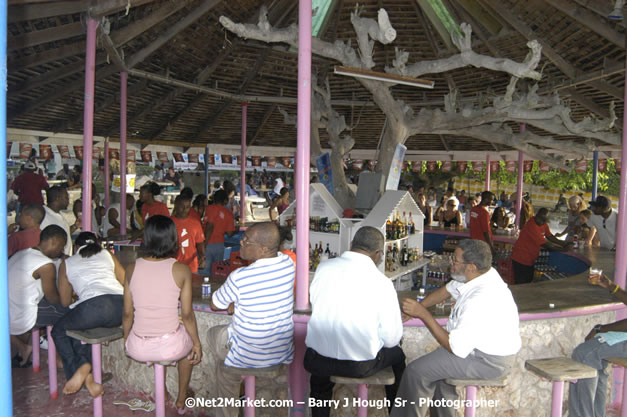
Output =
[{"x1": 568, "y1": 337, "x2": 627, "y2": 417}]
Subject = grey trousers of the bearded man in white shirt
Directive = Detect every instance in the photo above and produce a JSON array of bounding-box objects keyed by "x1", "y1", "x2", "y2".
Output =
[{"x1": 390, "y1": 347, "x2": 515, "y2": 417}]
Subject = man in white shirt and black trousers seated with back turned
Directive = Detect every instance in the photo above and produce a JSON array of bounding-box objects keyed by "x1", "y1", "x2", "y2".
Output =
[{"x1": 304, "y1": 226, "x2": 405, "y2": 417}]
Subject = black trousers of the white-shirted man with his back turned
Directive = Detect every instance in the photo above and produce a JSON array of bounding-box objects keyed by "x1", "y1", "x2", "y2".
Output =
[{"x1": 304, "y1": 346, "x2": 405, "y2": 417}]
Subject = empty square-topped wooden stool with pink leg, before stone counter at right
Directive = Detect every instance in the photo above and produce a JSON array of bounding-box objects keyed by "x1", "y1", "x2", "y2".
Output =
[{"x1": 525, "y1": 357, "x2": 597, "y2": 417}]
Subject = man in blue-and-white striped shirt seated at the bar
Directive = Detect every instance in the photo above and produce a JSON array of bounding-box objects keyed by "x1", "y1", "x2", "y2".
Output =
[{"x1": 208, "y1": 223, "x2": 295, "y2": 417}]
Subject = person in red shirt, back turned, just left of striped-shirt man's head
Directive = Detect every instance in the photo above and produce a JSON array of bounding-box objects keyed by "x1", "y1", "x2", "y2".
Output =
[{"x1": 198, "y1": 190, "x2": 237, "y2": 276}]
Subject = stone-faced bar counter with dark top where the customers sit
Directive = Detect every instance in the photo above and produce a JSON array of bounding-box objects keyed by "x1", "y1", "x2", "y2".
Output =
[{"x1": 108, "y1": 244, "x2": 624, "y2": 417}]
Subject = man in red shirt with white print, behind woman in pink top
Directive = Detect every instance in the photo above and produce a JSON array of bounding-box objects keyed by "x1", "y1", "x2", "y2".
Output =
[{"x1": 171, "y1": 194, "x2": 205, "y2": 272}]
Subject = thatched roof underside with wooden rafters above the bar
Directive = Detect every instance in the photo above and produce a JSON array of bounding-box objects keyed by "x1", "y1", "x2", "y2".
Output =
[{"x1": 7, "y1": 0, "x2": 625, "y2": 155}]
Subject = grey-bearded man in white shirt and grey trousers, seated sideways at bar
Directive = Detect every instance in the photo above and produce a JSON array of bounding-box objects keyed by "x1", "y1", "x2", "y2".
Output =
[{"x1": 390, "y1": 239, "x2": 521, "y2": 417}]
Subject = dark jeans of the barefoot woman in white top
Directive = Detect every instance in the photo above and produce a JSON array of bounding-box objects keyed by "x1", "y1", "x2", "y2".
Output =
[{"x1": 52, "y1": 295, "x2": 124, "y2": 380}]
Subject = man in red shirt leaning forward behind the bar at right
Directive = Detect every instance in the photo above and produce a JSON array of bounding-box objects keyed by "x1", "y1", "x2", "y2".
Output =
[{"x1": 512, "y1": 207, "x2": 572, "y2": 284}]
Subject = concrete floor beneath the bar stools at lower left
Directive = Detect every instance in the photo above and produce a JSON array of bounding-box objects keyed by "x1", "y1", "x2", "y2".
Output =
[{"x1": 13, "y1": 351, "x2": 213, "y2": 417}]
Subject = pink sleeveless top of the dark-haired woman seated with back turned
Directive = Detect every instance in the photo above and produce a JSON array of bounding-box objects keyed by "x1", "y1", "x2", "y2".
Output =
[{"x1": 130, "y1": 258, "x2": 181, "y2": 337}]
